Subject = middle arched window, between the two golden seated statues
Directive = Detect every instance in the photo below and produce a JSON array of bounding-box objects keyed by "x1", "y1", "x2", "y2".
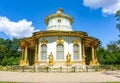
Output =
[{"x1": 56, "y1": 44, "x2": 64, "y2": 60}]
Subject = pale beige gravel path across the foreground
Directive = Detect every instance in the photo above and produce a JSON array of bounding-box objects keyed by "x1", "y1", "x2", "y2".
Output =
[{"x1": 0, "y1": 71, "x2": 120, "y2": 83}]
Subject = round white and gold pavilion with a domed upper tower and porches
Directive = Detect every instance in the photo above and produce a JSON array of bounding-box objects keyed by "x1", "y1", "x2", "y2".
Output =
[{"x1": 20, "y1": 9, "x2": 99, "y2": 66}]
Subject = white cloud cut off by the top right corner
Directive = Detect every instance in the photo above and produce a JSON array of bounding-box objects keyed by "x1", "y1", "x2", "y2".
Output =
[{"x1": 83, "y1": 0, "x2": 120, "y2": 14}]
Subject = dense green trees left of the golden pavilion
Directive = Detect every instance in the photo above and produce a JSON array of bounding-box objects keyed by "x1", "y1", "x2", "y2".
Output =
[{"x1": 0, "y1": 38, "x2": 21, "y2": 65}]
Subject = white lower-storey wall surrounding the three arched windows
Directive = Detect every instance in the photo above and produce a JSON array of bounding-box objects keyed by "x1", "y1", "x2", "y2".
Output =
[{"x1": 38, "y1": 36, "x2": 82, "y2": 61}]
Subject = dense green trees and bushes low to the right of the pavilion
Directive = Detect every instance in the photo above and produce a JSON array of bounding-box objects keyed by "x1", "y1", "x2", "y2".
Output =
[{"x1": 97, "y1": 42, "x2": 120, "y2": 64}]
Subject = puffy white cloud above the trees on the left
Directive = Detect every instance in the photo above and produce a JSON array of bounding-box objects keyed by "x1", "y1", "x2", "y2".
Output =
[{"x1": 0, "y1": 16, "x2": 38, "y2": 38}]
